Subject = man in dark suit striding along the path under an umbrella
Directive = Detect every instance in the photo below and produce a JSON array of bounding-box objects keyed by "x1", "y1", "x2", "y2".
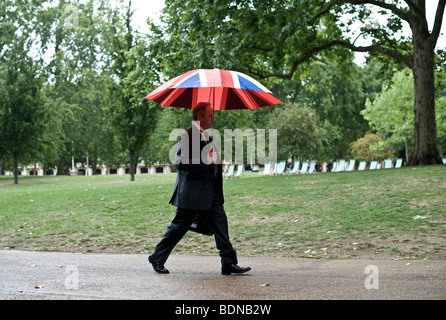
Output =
[{"x1": 149, "y1": 103, "x2": 251, "y2": 275}]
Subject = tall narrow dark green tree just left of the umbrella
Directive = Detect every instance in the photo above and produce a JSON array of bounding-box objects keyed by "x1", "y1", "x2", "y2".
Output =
[{"x1": 108, "y1": 0, "x2": 159, "y2": 181}]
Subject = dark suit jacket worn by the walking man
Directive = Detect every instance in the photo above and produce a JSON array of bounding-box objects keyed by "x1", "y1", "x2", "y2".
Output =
[{"x1": 169, "y1": 125, "x2": 224, "y2": 210}]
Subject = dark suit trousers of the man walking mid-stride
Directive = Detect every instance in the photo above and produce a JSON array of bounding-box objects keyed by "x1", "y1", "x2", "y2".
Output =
[{"x1": 152, "y1": 194, "x2": 238, "y2": 266}]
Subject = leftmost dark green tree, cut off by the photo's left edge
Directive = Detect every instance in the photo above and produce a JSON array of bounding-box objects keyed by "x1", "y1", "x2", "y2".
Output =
[{"x1": 0, "y1": 0, "x2": 49, "y2": 184}]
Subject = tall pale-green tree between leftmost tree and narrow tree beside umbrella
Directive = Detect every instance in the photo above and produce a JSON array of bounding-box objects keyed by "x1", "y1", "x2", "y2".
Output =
[{"x1": 40, "y1": 0, "x2": 120, "y2": 175}]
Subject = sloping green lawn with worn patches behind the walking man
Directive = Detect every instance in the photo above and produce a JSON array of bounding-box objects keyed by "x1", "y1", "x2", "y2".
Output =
[{"x1": 0, "y1": 166, "x2": 446, "y2": 259}]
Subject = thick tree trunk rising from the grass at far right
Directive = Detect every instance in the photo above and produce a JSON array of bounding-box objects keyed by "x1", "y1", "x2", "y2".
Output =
[{"x1": 408, "y1": 3, "x2": 441, "y2": 166}]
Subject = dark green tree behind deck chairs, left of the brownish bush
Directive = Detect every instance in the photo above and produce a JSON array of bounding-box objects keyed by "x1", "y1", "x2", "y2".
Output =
[{"x1": 296, "y1": 57, "x2": 369, "y2": 160}]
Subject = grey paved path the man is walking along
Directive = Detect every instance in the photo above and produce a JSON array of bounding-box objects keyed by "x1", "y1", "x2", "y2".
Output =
[{"x1": 0, "y1": 250, "x2": 446, "y2": 300}]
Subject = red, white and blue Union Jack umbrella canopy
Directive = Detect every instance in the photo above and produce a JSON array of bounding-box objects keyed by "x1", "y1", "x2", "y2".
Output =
[{"x1": 146, "y1": 69, "x2": 282, "y2": 110}]
